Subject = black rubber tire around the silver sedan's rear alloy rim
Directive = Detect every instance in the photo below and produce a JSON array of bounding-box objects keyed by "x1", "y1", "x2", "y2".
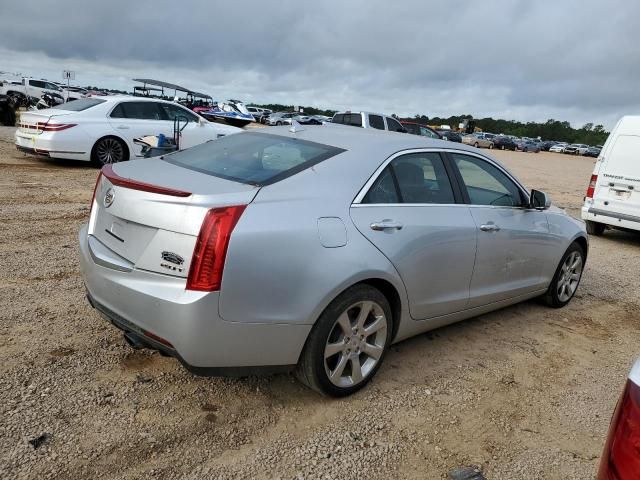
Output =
[{"x1": 300, "y1": 284, "x2": 393, "y2": 397}]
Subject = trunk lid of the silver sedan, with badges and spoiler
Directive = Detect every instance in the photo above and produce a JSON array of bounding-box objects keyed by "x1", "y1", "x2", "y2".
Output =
[{"x1": 89, "y1": 159, "x2": 259, "y2": 277}]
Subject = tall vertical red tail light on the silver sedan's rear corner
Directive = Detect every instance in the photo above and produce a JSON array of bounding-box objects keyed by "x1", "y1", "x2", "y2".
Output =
[{"x1": 187, "y1": 205, "x2": 247, "y2": 292}]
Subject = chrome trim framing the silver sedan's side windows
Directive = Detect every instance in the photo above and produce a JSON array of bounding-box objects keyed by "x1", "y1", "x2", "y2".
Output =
[{"x1": 351, "y1": 146, "x2": 530, "y2": 206}]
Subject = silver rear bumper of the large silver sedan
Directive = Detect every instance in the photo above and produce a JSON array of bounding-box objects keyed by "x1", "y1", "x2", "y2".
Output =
[{"x1": 79, "y1": 225, "x2": 311, "y2": 375}]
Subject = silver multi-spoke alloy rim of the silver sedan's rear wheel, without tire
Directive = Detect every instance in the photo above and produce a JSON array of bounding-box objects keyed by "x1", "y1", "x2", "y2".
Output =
[{"x1": 324, "y1": 300, "x2": 388, "y2": 388}]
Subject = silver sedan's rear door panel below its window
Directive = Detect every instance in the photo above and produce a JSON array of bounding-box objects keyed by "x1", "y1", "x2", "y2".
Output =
[{"x1": 351, "y1": 205, "x2": 476, "y2": 319}]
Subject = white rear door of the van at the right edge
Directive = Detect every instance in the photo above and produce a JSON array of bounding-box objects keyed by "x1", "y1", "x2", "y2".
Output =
[{"x1": 591, "y1": 135, "x2": 640, "y2": 221}]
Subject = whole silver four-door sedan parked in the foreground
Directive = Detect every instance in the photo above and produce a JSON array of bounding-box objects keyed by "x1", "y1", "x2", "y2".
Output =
[{"x1": 79, "y1": 127, "x2": 587, "y2": 396}]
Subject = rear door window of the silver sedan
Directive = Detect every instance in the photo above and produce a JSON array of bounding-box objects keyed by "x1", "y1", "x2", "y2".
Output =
[{"x1": 363, "y1": 152, "x2": 455, "y2": 204}]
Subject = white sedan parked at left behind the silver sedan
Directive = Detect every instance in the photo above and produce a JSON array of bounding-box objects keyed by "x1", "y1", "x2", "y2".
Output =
[{"x1": 15, "y1": 96, "x2": 242, "y2": 166}]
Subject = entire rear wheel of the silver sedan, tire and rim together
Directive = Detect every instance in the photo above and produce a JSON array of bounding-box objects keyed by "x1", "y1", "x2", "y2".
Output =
[{"x1": 296, "y1": 285, "x2": 393, "y2": 397}]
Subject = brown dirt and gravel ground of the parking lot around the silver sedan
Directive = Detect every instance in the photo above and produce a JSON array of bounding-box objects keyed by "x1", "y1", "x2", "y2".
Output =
[{"x1": 0, "y1": 128, "x2": 640, "y2": 480}]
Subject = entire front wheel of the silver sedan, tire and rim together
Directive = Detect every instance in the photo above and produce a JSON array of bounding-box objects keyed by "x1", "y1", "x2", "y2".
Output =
[{"x1": 542, "y1": 242, "x2": 585, "y2": 308}]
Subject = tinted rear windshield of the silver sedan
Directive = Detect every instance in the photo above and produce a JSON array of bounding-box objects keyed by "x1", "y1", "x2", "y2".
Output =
[{"x1": 163, "y1": 132, "x2": 344, "y2": 186}]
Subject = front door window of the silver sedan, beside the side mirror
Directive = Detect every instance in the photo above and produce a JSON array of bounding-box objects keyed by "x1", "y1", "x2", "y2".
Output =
[{"x1": 453, "y1": 153, "x2": 525, "y2": 207}]
